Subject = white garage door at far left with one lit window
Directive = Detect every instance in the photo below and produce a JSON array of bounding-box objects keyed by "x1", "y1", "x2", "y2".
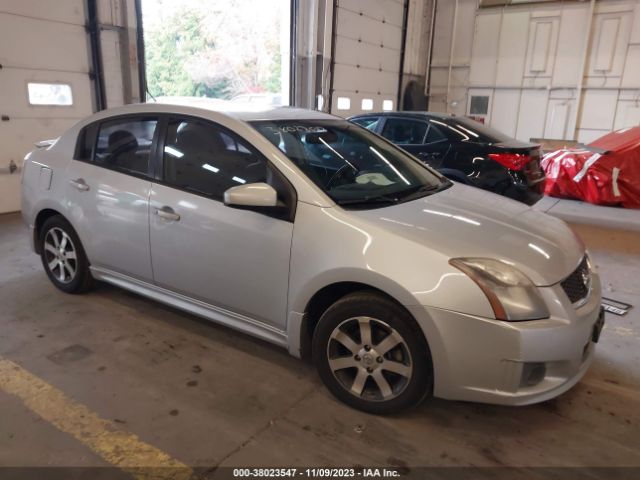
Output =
[{"x1": 0, "y1": 0, "x2": 92, "y2": 213}]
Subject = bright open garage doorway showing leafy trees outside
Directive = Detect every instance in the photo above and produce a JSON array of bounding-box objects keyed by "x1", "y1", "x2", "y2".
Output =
[{"x1": 144, "y1": 0, "x2": 286, "y2": 98}]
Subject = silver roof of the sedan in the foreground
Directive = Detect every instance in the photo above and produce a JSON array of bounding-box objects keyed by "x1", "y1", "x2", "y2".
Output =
[{"x1": 97, "y1": 97, "x2": 344, "y2": 122}]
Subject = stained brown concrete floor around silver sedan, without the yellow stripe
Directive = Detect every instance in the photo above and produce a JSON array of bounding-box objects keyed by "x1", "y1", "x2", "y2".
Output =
[{"x1": 0, "y1": 214, "x2": 640, "y2": 478}]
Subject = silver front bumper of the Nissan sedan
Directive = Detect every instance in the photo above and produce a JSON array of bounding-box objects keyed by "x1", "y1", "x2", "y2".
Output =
[{"x1": 408, "y1": 275, "x2": 604, "y2": 405}]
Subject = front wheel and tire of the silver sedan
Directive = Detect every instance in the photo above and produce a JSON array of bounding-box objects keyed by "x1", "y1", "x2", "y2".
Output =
[{"x1": 312, "y1": 291, "x2": 433, "y2": 414}]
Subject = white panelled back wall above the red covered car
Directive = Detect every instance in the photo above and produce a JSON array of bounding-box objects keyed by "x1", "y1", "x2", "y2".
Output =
[{"x1": 429, "y1": 0, "x2": 640, "y2": 142}]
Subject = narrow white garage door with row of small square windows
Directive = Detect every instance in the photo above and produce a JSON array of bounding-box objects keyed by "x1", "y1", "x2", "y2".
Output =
[{"x1": 331, "y1": 0, "x2": 405, "y2": 117}]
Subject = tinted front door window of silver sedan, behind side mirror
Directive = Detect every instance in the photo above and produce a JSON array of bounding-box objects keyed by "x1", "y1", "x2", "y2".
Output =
[{"x1": 164, "y1": 119, "x2": 267, "y2": 199}]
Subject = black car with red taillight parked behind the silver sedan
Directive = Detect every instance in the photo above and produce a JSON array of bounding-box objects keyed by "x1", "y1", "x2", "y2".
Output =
[{"x1": 349, "y1": 112, "x2": 544, "y2": 205}]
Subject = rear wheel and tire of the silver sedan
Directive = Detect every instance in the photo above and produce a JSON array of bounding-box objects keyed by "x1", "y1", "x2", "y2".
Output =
[{"x1": 38, "y1": 215, "x2": 93, "y2": 293}]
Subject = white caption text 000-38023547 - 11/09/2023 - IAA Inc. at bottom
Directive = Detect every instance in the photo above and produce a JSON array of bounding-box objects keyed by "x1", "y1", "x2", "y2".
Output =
[{"x1": 233, "y1": 467, "x2": 401, "y2": 478}]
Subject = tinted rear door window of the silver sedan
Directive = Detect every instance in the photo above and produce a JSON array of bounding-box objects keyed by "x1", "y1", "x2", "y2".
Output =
[{"x1": 94, "y1": 118, "x2": 158, "y2": 175}]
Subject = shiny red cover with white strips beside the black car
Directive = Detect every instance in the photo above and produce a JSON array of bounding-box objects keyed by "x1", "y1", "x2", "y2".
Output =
[{"x1": 541, "y1": 127, "x2": 640, "y2": 208}]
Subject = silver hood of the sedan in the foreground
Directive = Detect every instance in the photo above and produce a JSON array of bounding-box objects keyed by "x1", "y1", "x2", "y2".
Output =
[{"x1": 350, "y1": 184, "x2": 585, "y2": 286}]
